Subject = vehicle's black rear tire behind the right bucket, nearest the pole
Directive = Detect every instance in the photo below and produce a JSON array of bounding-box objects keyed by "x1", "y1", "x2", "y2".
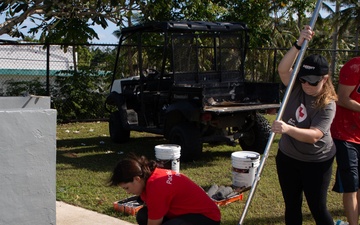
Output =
[{"x1": 239, "y1": 113, "x2": 271, "y2": 154}]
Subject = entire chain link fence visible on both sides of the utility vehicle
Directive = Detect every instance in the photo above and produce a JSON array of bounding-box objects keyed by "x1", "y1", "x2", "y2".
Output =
[{"x1": 0, "y1": 43, "x2": 359, "y2": 122}]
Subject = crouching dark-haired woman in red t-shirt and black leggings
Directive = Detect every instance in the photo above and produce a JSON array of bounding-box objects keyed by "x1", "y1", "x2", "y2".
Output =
[{"x1": 110, "y1": 155, "x2": 220, "y2": 225}]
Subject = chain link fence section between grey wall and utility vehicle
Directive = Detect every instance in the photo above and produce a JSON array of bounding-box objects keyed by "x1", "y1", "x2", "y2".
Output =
[{"x1": 0, "y1": 43, "x2": 116, "y2": 122}]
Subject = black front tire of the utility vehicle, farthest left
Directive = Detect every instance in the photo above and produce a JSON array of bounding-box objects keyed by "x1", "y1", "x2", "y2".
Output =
[{"x1": 109, "y1": 111, "x2": 130, "y2": 143}]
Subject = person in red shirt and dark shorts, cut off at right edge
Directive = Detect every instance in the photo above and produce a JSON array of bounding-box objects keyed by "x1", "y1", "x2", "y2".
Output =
[{"x1": 331, "y1": 56, "x2": 360, "y2": 225}]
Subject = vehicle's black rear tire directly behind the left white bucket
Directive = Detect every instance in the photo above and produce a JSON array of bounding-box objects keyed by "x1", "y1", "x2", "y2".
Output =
[{"x1": 169, "y1": 123, "x2": 202, "y2": 162}]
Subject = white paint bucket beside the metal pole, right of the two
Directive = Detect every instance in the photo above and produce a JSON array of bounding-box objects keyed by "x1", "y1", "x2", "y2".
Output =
[{"x1": 231, "y1": 151, "x2": 260, "y2": 188}]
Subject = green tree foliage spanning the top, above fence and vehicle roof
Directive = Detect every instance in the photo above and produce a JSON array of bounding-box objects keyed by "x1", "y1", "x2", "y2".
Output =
[{"x1": 0, "y1": 0, "x2": 360, "y2": 53}]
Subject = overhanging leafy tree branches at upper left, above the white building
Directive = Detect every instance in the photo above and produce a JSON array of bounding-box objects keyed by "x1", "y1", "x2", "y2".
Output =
[{"x1": 0, "y1": 0, "x2": 133, "y2": 43}]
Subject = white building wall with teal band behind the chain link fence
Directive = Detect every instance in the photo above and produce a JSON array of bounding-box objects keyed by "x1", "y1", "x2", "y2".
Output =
[{"x1": 0, "y1": 44, "x2": 77, "y2": 96}]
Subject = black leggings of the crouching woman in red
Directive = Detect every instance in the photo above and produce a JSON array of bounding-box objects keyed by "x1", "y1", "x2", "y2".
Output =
[{"x1": 136, "y1": 206, "x2": 220, "y2": 225}]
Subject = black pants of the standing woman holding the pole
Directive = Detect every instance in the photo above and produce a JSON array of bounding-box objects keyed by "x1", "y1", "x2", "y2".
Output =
[{"x1": 276, "y1": 150, "x2": 334, "y2": 225}]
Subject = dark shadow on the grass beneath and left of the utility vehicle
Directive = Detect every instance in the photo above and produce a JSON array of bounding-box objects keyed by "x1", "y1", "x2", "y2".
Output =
[{"x1": 57, "y1": 136, "x2": 240, "y2": 172}]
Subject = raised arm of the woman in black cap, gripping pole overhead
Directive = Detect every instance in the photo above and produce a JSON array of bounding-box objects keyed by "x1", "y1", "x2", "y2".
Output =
[{"x1": 278, "y1": 25, "x2": 315, "y2": 86}]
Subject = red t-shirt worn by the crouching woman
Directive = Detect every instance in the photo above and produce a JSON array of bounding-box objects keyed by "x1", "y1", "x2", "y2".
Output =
[{"x1": 141, "y1": 168, "x2": 221, "y2": 221}]
